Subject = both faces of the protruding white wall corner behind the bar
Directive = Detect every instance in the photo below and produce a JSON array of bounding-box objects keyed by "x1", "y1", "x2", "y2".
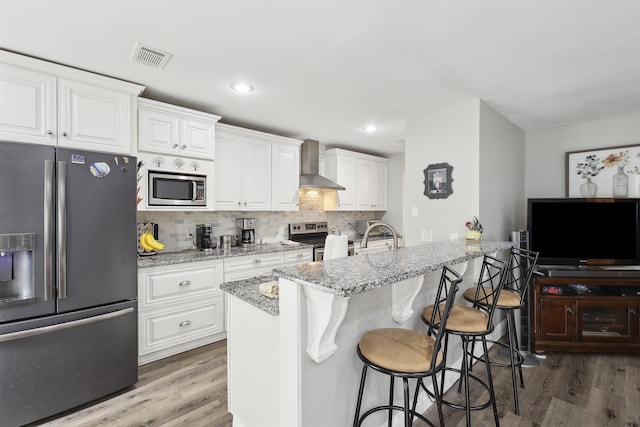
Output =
[{"x1": 404, "y1": 100, "x2": 526, "y2": 246}]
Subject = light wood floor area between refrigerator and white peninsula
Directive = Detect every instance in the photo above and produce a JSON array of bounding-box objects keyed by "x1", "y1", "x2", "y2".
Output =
[{"x1": 32, "y1": 340, "x2": 232, "y2": 427}]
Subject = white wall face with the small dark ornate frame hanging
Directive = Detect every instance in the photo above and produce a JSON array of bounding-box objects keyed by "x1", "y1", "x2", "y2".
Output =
[{"x1": 403, "y1": 100, "x2": 480, "y2": 246}]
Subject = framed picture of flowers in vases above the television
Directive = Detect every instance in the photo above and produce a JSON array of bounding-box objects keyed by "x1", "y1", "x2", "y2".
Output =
[{"x1": 565, "y1": 145, "x2": 640, "y2": 198}]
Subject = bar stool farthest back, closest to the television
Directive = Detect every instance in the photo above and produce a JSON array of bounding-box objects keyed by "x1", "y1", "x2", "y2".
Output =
[{"x1": 463, "y1": 247, "x2": 538, "y2": 415}]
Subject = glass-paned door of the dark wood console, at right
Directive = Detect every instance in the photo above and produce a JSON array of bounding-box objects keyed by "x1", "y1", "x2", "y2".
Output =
[{"x1": 578, "y1": 301, "x2": 638, "y2": 342}]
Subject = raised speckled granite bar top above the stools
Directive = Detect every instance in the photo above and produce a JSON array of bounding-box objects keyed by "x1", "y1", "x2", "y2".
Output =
[{"x1": 274, "y1": 239, "x2": 513, "y2": 297}]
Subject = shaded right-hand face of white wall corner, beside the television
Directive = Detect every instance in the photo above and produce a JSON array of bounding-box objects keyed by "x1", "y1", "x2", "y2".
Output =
[{"x1": 478, "y1": 102, "x2": 526, "y2": 240}]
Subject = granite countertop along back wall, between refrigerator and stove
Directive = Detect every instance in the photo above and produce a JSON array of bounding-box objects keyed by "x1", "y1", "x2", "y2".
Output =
[{"x1": 138, "y1": 243, "x2": 313, "y2": 268}]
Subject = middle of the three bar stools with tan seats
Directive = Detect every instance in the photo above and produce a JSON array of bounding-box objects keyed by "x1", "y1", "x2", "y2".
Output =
[{"x1": 422, "y1": 255, "x2": 507, "y2": 426}]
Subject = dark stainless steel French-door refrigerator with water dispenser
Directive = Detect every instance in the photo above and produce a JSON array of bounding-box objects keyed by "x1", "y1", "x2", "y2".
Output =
[{"x1": 0, "y1": 142, "x2": 138, "y2": 427}]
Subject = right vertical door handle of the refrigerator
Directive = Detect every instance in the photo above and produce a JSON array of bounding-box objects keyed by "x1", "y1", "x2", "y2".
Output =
[{"x1": 56, "y1": 161, "x2": 67, "y2": 299}]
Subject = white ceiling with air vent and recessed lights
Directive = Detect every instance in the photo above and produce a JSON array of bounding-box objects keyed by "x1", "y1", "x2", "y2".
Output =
[{"x1": 0, "y1": 0, "x2": 640, "y2": 154}]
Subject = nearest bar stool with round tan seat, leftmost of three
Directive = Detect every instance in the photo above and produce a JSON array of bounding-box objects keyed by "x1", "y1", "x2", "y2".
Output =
[{"x1": 353, "y1": 267, "x2": 462, "y2": 427}]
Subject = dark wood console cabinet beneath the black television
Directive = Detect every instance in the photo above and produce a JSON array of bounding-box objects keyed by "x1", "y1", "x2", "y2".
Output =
[{"x1": 532, "y1": 277, "x2": 640, "y2": 353}]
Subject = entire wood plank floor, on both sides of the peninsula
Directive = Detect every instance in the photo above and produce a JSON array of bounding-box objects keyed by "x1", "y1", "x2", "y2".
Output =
[{"x1": 31, "y1": 341, "x2": 640, "y2": 427}]
